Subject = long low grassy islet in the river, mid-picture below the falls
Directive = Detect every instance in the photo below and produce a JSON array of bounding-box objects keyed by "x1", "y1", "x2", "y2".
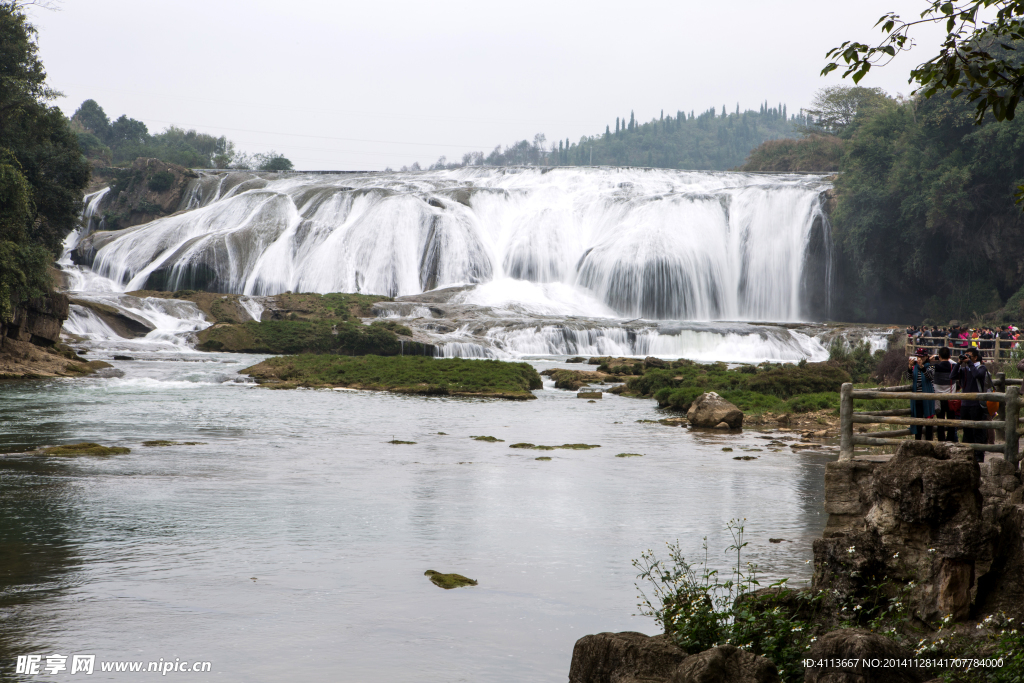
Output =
[{"x1": 243, "y1": 354, "x2": 543, "y2": 399}]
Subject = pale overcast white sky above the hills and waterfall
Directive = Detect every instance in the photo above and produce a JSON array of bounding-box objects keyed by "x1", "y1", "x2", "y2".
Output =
[{"x1": 30, "y1": 0, "x2": 941, "y2": 170}]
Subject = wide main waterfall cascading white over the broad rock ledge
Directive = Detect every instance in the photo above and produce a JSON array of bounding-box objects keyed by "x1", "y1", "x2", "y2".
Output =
[{"x1": 77, "y1": 168, "x2": 828, "y2": 321}]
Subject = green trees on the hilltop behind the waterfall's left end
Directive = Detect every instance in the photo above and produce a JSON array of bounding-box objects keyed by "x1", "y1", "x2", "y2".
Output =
[{"x1": 71, "y1": 99, "x2": 292, "y2": 171}]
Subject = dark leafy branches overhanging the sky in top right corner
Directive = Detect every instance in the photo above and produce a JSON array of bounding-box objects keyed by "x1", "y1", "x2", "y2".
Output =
[{"x1": 821, "y1": 0, "x2": 1024, "y2": 123}]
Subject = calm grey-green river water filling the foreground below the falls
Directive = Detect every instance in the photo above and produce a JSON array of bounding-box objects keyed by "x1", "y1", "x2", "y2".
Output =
[{"x1": 0, "y1": 345, "x2": 831, "y2": 683}]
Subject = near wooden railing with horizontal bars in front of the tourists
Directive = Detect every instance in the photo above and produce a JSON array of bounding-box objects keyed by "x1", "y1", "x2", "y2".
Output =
[{"x1": 839, "y1": 373, "x2": 1024, "y2": 464}]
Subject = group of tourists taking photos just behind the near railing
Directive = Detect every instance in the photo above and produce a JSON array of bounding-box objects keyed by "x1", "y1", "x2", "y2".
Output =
[{"x1": 906, "y1": 346, "x2": 999, "y2": 462}]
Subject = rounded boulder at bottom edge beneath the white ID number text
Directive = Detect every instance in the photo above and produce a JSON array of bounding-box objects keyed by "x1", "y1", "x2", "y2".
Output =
[{"x1": 804, "y1": 629, "x2": 928, "y2": 683}]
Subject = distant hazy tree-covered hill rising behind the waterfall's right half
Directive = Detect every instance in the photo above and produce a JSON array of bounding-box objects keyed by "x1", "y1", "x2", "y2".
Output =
[{"x1": 402, "y1": 102, "x2": 811, "y2": 171}]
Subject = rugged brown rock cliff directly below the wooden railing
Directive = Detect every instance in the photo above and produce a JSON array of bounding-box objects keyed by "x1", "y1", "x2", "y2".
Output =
[{"x1": 814, "y1": 441, "x2": 1024, "y2": 622}]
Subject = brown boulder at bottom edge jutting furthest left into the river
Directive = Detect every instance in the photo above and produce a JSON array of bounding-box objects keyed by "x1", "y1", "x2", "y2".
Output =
[{"x1": 569, "y1": 631, "x2": 686, "y2": 683}]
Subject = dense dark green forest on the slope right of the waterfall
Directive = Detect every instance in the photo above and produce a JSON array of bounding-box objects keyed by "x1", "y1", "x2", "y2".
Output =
[{"x1": 834, "y1": 89, "x2": 1024, "y2": 323}]
